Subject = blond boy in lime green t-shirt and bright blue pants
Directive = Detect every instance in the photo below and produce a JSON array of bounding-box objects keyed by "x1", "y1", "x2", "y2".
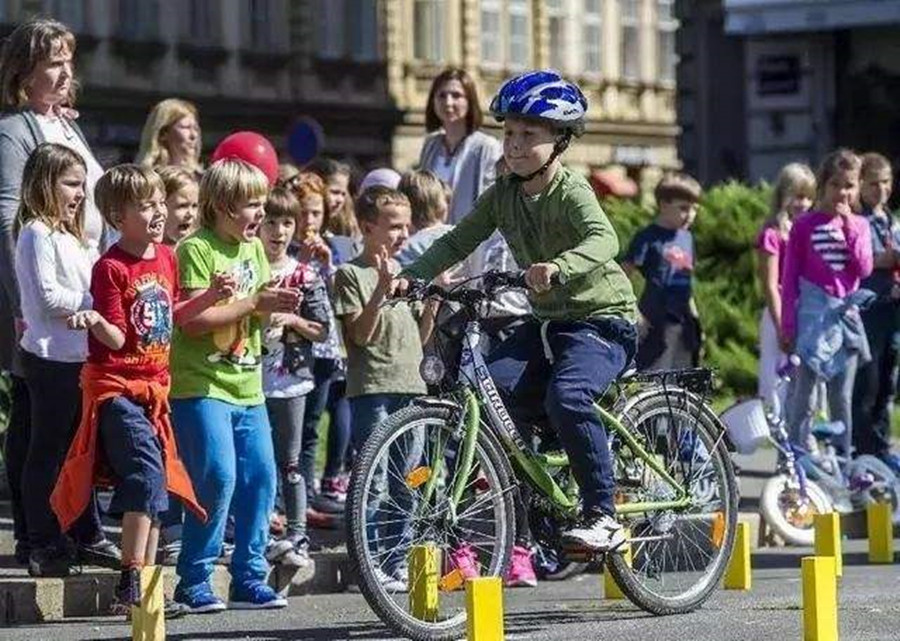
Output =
[{"x1": 171, "y1": 159, "x2": 299, "y2": 612}]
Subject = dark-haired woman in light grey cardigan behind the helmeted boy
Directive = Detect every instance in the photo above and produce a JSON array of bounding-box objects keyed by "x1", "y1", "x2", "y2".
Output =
[{"x1": 419, "y1": 67, "x2": 503, "y2": 225}]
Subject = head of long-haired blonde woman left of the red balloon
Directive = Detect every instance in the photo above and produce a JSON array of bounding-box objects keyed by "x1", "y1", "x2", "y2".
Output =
[{"x1": 136, "y1": 98, "x2": 203, "y2": 174}]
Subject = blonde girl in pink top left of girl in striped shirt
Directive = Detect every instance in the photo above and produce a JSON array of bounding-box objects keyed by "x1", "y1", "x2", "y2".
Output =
[{"x1": 756, "y1": 163, "x2": 816, "y2": 407}]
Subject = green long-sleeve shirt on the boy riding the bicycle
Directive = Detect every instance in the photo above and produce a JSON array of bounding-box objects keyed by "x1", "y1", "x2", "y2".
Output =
[{"x1": 404, "y1": 167, "x2": 635, "y2": 320}]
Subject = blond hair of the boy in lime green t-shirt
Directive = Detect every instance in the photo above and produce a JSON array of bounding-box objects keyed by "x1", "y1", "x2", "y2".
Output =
[{"x1": 200, "y1": 158, "x2": 269, "y2": 229}]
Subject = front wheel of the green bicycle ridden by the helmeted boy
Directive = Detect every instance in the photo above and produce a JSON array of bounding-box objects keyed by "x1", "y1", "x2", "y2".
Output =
[{"x1": 347, "y1": 404, "x2": 515, "y2": 641}]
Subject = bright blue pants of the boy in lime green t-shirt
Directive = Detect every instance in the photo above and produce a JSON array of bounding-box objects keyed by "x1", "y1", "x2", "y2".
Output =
[{"x1": 172, "y1": 398, "x2": 275, "y2": 591}]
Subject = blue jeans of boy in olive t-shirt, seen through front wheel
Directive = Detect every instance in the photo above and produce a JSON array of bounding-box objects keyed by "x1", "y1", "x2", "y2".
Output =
[{"x1": 350, "y1": 394, "x2": 424, "y2": 574}]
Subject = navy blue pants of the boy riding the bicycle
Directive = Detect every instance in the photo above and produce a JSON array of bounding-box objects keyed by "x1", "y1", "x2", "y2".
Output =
[{"x1": 488, "y1": 319, "x2": 637, "y2": 514}]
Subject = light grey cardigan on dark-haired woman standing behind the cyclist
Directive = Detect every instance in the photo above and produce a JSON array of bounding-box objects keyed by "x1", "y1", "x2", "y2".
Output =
[{"x1": 419, "y1": 129, "x2": 503, "y2": 225}]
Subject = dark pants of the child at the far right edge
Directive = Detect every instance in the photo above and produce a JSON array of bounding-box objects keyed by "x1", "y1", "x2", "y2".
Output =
[{"x1": 853, "y1": 302, "x2": 897, "y2": 456}]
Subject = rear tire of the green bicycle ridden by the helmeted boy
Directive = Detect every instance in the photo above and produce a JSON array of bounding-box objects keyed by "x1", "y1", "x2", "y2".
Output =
[{"x1": 606, "y1": 390, "x2": 738, "y2": 616}]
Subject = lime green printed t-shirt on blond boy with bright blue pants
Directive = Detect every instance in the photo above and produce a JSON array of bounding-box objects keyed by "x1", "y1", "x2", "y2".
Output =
[{"x1": 171, "y1": 228, "x2": 269, "y2": 405}]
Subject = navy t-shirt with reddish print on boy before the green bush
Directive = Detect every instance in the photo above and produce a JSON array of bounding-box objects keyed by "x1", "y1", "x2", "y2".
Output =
[{"x1": 624, "y1": 223, "x2": 694, "y2": 324}]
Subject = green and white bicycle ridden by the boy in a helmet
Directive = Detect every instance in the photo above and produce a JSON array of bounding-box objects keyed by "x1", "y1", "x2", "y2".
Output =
[{"x1": 347, "y1": 273, "x2": 738, "y2": 640}]
